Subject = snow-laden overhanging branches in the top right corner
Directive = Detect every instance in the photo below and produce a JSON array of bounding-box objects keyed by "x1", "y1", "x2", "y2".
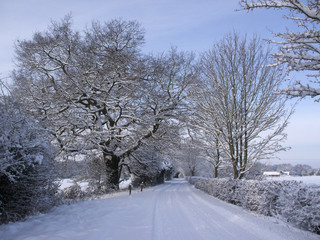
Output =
[{"x1": 240, "y1": 0, "x2": 320, "y2": 100}]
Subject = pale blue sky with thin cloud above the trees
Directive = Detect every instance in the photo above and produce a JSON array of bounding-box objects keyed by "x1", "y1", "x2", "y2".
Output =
[{"x1": 0, "y1": 0, "x2": 320, "y2": 167}]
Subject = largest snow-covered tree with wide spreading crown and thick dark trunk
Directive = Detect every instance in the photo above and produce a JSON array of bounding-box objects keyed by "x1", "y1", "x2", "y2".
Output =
[{"x1": 13, "y1": 17, "x2": 193, "y2": 188}]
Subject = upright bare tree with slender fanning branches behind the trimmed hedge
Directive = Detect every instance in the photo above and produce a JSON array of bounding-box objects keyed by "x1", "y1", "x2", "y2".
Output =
[{"x1": 192, "y1": 33, "x2": 290, "y2": 178}]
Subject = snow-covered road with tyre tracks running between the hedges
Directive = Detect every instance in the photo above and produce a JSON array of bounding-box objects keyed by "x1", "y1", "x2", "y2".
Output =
[{"x1": 0, "y1": 180, "x2": 320, "y2": 240}]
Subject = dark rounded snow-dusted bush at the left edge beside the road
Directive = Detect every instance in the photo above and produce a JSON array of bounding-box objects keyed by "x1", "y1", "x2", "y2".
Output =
[{"x1": 0, "y1": 103, "x2": 57, "y2": 223}]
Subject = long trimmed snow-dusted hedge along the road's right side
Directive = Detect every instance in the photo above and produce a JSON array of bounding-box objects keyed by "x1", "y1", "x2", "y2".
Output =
[{"x1": 188, "y1": 178, "x2": 320, "y2": 234}]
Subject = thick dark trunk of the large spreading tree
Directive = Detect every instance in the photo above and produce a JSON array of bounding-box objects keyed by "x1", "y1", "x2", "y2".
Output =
[{"x1": 103, "y1": 153, "x2": 120, "y2": 189}]
